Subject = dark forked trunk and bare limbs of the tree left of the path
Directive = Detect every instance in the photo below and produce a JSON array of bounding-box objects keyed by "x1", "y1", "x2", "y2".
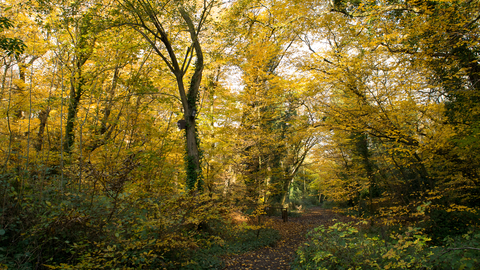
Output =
[{"x1": 119, "y1": 0, "x2": 209, "y2": 191}]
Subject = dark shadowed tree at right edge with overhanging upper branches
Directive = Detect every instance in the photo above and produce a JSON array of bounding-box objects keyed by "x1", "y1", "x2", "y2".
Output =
[{"x1": 333, "y1": 0, "x2": 480, "y2": 205}]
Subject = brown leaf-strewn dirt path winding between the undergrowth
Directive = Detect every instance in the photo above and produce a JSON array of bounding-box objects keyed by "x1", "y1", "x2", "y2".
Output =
[{"x1": 224, "y1": 207, "x2": 352, "y2": 270}]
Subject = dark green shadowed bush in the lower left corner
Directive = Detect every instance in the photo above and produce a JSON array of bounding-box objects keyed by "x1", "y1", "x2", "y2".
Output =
[{"x1": 0, "y1": 178, "x2": 124, "y2": 269}]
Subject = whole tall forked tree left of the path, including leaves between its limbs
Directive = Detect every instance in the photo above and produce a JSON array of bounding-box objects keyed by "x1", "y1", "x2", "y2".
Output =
[{"x1": 116, "y1": 0, "x2": 216, "y2": 190}]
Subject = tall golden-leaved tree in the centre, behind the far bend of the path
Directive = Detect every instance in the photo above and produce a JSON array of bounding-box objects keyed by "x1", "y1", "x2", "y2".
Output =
[{"x1": 216, "y1": 1, "x2": 316, "y2": 204}]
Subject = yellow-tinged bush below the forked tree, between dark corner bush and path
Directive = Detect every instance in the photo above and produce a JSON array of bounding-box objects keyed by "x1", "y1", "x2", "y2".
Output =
[{"x1": 40, "y1": 194, "x2": 222, "y2": 269}]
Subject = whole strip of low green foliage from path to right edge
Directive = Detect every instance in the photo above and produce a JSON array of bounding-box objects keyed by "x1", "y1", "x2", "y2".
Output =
[{"x1": 292, "y1": 222, "x2": 480, "y2": 269}]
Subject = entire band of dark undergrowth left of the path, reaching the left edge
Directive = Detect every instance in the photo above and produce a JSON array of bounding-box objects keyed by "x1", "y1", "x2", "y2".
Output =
[{"x1": 0, "y1": 175, "x2": 279, "y2": 269}]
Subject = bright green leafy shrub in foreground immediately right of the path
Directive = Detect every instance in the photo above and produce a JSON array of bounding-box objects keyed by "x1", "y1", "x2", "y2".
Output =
[{"x1": 293, "y1": 222, "x2": 433, "y2": 269}]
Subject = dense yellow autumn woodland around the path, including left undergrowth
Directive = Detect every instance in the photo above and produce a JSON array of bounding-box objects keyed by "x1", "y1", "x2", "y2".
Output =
[{"x1": 0, "y1": 0, "x2": 480, "y2": 269}]
